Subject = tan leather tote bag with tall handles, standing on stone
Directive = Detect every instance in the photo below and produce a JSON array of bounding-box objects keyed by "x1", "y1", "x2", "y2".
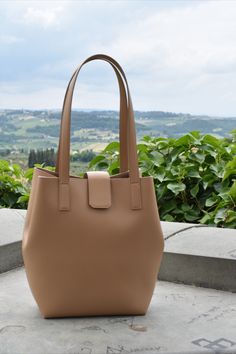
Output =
[{"x1": 22, "y1": 54, "x2": 163, "y2": 318}]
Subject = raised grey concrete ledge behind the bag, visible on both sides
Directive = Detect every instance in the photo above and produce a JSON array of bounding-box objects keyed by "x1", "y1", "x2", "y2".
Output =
[{"x1": 0, "y1": 209, "x2": 236, "y2": 292}]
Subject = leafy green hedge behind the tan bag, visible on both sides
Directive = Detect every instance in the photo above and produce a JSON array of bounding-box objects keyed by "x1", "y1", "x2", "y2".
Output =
[{"x1": 0, "y1": 131, "x2": 236, "y2": 228}]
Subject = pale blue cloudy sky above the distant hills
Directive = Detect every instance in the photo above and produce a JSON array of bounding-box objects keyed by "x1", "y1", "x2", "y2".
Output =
[{"x1": 0, "y1": 0, "x2": 236, "y2": 116}]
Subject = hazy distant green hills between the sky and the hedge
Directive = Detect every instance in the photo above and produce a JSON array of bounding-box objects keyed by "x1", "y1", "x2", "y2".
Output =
[{"x1": 0, "y1": 109, "x2": 236, "y2": 173}]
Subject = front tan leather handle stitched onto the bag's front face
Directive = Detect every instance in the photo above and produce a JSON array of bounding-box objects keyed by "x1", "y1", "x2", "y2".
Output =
[{"x1": 58, "y1": 54, "x2": 141, "y2": 210}]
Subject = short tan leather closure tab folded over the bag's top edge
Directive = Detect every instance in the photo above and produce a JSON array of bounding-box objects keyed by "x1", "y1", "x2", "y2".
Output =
[{"x1": 85, "y1": 171, "x2": 111, "y2": 209}]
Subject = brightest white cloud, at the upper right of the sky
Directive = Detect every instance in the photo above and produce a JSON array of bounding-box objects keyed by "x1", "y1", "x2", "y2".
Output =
[{"x1": 104, "y1": 1, "x2": 236, "y2": 73}]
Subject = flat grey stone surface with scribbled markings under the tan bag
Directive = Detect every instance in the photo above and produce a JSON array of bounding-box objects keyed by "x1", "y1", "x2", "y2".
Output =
[{"x1": 0, "y1": 268, "x2": 236, "y2": 354}]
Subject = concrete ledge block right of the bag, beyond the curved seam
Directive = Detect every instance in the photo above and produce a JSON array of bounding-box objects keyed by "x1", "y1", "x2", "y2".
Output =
[{"x1": 159, "y1": 224, "x2": 236, "y2": 292}]
